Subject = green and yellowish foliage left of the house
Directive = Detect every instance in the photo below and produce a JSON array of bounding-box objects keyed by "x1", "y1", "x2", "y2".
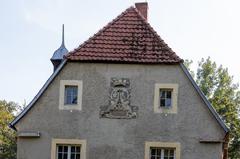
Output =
[{"x1": 0, "y1": 100, "x2": 19, "y2": 159}]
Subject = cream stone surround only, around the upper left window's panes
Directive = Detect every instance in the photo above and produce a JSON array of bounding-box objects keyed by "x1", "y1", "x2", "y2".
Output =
[{"x1": 59, "y1": 80, "x2": 83, "y2": 110}]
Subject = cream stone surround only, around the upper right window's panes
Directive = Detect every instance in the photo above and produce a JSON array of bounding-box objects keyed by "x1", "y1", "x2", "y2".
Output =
[{"x1": 153, "y1": 83, "x2": 178, "y2": 114}]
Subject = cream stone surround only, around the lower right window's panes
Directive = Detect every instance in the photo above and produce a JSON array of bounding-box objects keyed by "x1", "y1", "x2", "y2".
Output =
[{"x1": 144, "y1": 142, "x2": 180, "y2": 159}]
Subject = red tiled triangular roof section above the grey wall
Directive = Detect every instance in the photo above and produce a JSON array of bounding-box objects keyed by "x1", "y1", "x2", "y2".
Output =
[{"x1": 65, "y1": 7, "x2": 183, "y2": 64}]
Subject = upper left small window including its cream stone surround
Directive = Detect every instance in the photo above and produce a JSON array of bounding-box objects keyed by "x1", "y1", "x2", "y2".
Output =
[{"x1": 59, "y1": 80, "x2": 82, "y2": 110}]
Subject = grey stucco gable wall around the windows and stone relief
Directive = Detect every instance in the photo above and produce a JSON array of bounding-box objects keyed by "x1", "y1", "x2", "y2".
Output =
[{"x1": 15, "y1": 62, "x2": 225, "y2": 159}]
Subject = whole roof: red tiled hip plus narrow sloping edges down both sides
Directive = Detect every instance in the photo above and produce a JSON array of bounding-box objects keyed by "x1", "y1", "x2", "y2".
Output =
[{"x1": 10, "y1": 4, "x2": 229, "y2": 135}]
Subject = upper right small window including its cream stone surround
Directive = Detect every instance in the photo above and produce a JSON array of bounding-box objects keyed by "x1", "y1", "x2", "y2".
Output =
[{"x1": 154, "y1": 83, "x2": 178, "y2": 113}]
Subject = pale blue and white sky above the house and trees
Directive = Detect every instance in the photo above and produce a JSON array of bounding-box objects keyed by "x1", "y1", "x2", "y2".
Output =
[{"x1": 0, "y1": 0, "x2": 240, "y2": 104}]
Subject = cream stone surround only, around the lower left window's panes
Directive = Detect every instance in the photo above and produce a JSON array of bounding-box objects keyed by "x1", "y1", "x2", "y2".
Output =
[{"x1": 51, "y1": 139, "x2": 87, "y2": 159}]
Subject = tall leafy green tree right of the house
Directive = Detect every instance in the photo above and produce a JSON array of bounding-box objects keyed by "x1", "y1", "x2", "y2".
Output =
[{"x1": 186, "y1": 57, "x2": 240, "y2": 159}]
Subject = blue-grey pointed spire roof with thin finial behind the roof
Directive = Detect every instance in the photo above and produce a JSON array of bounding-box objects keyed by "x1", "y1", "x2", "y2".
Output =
[{"x1": 51, "y1": 24, "x2": 68, "y2": 61}]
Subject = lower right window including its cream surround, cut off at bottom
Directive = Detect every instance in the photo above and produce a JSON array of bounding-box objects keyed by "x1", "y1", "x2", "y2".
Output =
[{"x1": 144, "y1": 142, "x2": 180, "y2": 159}]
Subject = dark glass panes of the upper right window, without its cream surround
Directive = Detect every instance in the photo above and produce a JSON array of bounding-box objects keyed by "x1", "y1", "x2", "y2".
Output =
[{"x1": 160, "y1": 89, "x2": 172, "y2": 108}]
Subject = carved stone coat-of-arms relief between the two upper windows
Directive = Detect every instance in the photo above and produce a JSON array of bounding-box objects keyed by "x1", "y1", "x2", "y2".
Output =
[{"x1": 100, "y1": 78, "x2": 138, "y2": 119}]
